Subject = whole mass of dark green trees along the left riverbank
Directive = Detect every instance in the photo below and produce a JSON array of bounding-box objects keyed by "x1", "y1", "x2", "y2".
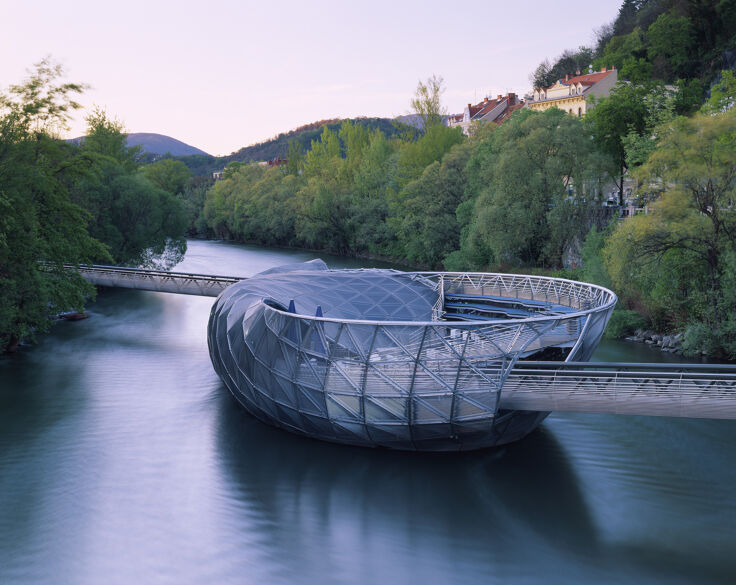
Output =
[{"x1": 0, "y1": 59, "x2": 186, "y2": 351}]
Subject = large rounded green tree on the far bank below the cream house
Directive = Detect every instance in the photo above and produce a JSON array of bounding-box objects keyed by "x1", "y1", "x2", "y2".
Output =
[{"x1": 452, "y1": 108, "x2": 597, "y2": 268}]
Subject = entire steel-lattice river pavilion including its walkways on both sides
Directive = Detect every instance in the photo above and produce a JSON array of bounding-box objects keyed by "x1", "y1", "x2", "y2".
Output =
[{"x1": 73, "y1": 261, "x2": 736, "y2": 450}]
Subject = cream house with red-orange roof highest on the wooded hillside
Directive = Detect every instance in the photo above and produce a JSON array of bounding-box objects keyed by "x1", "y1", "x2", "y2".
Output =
[{"x1": 526, "y1": 67, "x2": 618, "y2": 116}]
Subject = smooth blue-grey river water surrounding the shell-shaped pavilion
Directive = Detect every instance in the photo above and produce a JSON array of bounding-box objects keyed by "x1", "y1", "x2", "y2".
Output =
[{"x1": 0, "y1": 241, "x2": 736, "y2": 585}]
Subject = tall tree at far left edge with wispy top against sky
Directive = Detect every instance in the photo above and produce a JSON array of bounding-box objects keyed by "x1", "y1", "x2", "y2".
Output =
[{"x1": 0, "y1": 59, "x2": 109, "y2": 351}]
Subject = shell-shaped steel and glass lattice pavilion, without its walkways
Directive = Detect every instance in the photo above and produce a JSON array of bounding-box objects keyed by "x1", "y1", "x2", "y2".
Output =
[{"x1": 208, "y1": 262, "x2": 616, "y2": 450}]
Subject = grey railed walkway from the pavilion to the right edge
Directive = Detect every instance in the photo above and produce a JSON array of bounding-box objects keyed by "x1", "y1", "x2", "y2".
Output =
[{"x1": 500, "y1": 361, "x2": 736, "y2": 420}]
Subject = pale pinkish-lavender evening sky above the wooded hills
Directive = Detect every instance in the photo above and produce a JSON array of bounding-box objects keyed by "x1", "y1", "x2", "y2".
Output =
[{"x1": 0, "y1": 0, "x2": 621, "y2": 155}]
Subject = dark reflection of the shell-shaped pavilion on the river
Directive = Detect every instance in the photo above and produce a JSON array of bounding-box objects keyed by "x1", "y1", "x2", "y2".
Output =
[{"x1": 217, "y1": 388, "x2": 597, "y2": 582}]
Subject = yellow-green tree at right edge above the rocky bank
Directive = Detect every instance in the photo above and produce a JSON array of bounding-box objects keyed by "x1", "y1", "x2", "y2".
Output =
[{"x1": 604, "y1": 110, "x2": 736, "y2": 354}]
